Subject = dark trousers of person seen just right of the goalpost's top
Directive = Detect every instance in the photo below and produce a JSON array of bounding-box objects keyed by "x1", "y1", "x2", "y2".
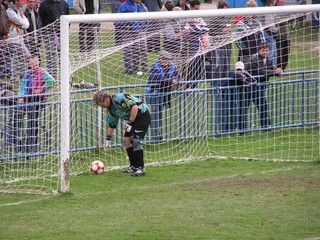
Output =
[{"x1": 79, "y1": 23, "x2": 96, "y2": 52}]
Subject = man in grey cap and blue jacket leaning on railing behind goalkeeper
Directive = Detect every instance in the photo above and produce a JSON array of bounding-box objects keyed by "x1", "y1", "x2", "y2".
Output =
[{"x1": 146, "y1": 50, "x2": 180, "y2": 140}]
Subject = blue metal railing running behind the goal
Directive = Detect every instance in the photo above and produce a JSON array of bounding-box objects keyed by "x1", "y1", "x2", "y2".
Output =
[{"x1": 0, "y1": 71, "x2": 319, "y2": 160}]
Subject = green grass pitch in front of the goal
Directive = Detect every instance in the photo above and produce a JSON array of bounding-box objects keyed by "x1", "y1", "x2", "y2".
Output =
[{"x1": 0, "y1": 159, "x2": 320, "y2": 240}]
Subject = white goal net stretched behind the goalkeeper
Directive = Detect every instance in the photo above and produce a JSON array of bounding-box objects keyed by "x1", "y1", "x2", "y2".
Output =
[{"x1": 0, "y1": 5, "x2": 320, "y2": 193}]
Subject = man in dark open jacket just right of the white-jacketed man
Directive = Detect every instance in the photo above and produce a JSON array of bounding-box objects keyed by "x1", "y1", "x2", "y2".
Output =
[{"x1": 24, "y1": 0, "x2": 42, "y2": 57}]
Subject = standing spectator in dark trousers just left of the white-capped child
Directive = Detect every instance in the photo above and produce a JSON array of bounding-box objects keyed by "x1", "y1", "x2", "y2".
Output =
[{"x1": 206, "y1": 0, "x2": 232, "y2": 86}]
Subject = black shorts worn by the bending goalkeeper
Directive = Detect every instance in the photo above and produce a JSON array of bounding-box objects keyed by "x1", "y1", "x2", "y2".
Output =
[{"x1": 124, "y1": 111, "x2": 151, "y2": 139}]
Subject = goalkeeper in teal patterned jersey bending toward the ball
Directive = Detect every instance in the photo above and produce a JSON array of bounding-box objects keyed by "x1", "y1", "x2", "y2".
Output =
[{"x1": 92, "y1": 91, "x2": 151, "y2": 176}]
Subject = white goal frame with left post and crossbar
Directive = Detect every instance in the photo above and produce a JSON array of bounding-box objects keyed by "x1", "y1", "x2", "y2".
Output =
[{"x1": 60, "y1": 4, "x2": 320, "y2": 193}]
